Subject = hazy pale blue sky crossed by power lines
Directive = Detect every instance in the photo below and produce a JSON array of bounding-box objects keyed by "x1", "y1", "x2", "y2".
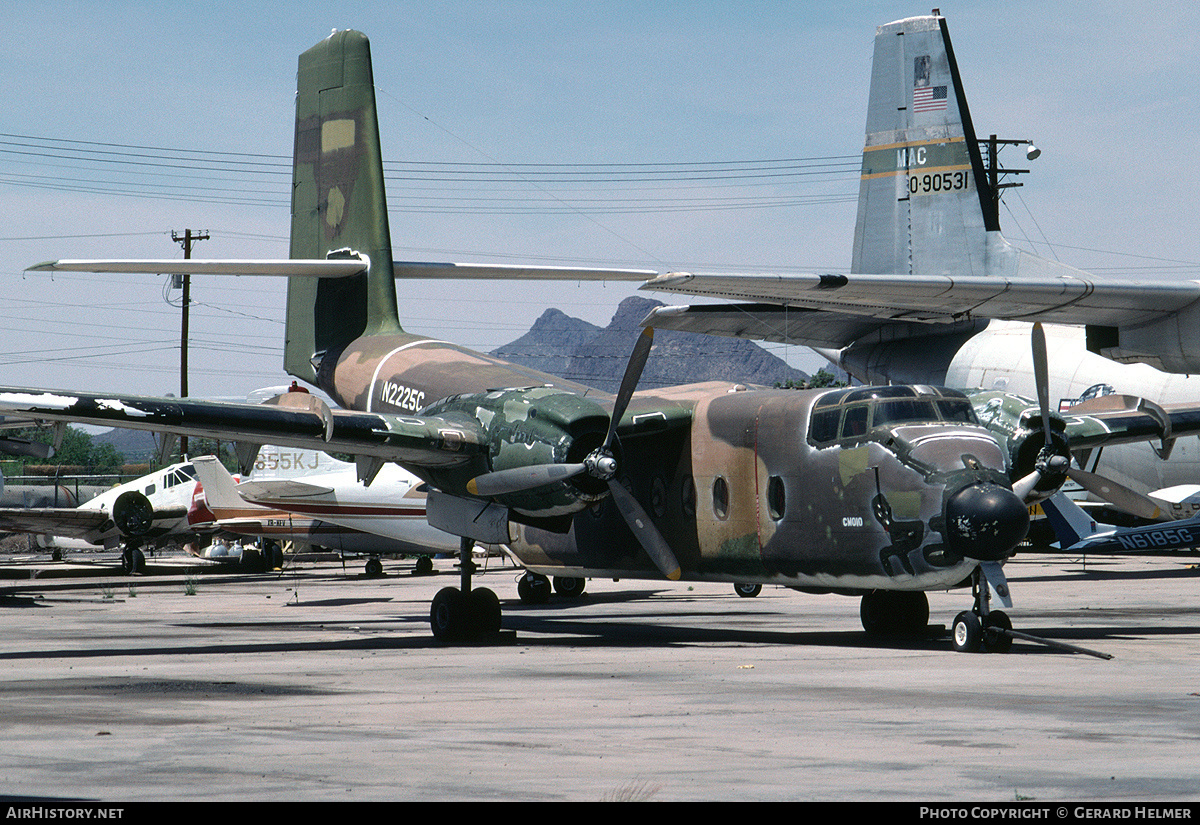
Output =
[{"x1": 0, "y1": 0, "x2": 1200, "y2": 396}]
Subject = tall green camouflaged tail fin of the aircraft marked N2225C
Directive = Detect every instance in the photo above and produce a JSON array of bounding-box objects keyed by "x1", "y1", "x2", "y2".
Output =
[{"x1": 284, "y1": 31, "x2": 401, "y2": 384}]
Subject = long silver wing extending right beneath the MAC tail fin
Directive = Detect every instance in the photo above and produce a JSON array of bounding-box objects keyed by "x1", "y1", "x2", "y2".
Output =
[{"x1": 641, "y1": 272, "x2": 1200, "y2": 347}]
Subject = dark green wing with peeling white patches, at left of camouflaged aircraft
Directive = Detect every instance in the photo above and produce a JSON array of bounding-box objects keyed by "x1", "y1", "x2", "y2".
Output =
[{"x1": 0, "y1": 387, "x2": 486, "y2": 466}]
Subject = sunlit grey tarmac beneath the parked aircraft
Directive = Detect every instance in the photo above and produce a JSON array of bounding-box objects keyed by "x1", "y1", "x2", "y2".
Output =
[{"x1": 0, "y1": 546, "x2": 1200, "y2": 802}]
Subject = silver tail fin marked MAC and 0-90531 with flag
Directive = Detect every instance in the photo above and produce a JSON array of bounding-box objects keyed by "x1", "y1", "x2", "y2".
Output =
[{"x1": 851, "y1": 17, "x2": 1001, "y2": 275}]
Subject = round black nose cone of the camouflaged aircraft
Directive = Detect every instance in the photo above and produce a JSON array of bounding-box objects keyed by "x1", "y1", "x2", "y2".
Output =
[{"x1": 946, "y1": 482, "x2": 1030, "y2": 561}]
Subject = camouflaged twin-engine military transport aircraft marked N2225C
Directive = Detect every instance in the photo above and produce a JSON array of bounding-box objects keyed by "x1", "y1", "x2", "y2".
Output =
[{"x1": 0, "y1": 24, "x2": 1190, "y2": 650}]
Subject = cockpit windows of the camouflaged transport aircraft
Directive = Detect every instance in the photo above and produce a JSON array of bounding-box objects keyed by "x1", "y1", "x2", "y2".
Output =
[{"x1": 809, "y1": 385, "x2": 979, "y2": 446}]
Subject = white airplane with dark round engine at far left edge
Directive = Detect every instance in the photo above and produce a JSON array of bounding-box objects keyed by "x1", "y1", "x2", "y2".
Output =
[{"x1": 0, "y1": 460, "x2": 196, "y2": 573}]
